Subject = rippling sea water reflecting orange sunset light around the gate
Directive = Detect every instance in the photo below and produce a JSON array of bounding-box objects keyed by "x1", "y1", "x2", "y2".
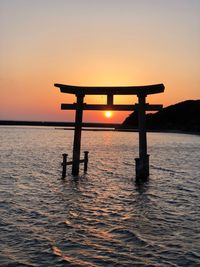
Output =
[{"x1": 0, "y1": 127, "x2": 200, "y2": 267}]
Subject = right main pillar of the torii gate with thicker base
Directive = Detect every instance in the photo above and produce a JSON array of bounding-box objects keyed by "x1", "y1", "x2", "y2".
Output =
[{"x1": 135, "y1": 94, "x2": 149, "y2": 179}]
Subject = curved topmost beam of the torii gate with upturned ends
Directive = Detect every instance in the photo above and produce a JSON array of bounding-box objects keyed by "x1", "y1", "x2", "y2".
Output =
[{"x1": 54, "y1": 83, "x2": 165, "y2": 96}]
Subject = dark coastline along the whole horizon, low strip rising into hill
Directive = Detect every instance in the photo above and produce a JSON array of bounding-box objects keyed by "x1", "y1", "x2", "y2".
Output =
[{"x1": 0, "y1": 100, "x2": 200, "y2": 134}]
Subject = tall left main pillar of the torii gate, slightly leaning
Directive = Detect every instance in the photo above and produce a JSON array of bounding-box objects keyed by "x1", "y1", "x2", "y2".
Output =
[{"x1": 72, "y1": 94, "x2": 84, "y2": 175}]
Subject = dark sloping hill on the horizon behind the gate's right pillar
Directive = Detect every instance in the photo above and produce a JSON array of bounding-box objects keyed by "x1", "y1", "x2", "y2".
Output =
[{"x1": 120, "y1": 100, "x2": 200, "y2": 133}]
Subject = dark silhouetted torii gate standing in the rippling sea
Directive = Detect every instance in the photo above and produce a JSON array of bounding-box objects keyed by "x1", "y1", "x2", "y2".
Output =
[{"x1": 54, "y1": 84, "x2": 165, "y2": 179}]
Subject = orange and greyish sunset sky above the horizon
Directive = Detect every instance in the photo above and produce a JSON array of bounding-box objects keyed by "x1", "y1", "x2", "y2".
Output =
[{"x1": 0, "y1": 0, "x2": 200, "y2": 123}]
